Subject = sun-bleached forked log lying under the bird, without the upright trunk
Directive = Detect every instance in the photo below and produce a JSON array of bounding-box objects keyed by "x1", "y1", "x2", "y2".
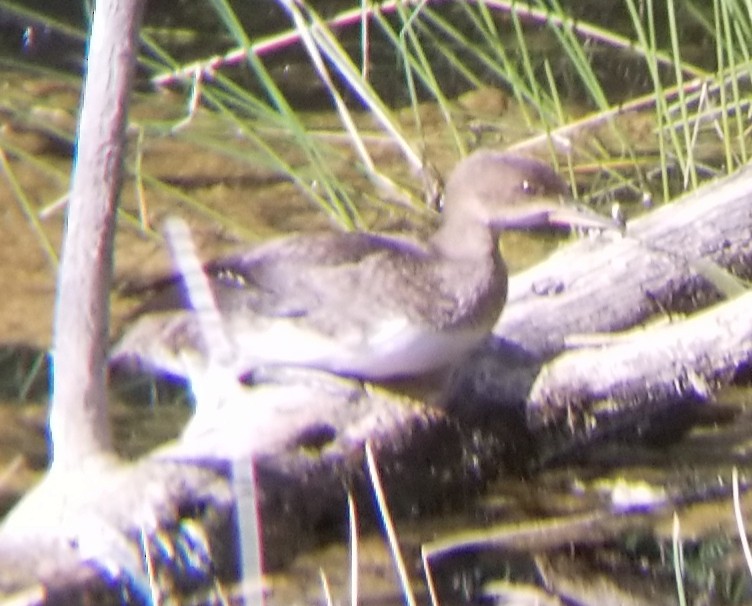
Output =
[{"x1": 0, "y1": 168, "x2": 752, "y2": 603}]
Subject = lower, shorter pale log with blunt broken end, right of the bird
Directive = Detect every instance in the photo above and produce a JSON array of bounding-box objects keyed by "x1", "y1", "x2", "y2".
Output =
[{"x1": 527, "y1": 293, "x2": 752, "y2": 448}]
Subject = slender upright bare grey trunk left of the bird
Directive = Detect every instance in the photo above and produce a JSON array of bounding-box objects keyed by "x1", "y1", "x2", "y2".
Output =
[{"x1": 50, "y1": 0, "x2": 145, "y2": 471}]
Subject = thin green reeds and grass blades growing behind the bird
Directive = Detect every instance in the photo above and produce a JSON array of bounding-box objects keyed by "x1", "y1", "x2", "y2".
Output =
[{"x1": 0, "y1": 0, "x2": 750, "y2": 250}]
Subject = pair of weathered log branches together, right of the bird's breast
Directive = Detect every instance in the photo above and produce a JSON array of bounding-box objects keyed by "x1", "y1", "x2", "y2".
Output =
[{"x1": 455, "y1": 167, "x2": 752, "y2": 458}]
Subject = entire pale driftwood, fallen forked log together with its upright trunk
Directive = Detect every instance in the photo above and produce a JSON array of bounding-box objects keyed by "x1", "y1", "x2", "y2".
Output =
[{"x1": 5, "y1": 2, "x2": 752, "y2": 604}]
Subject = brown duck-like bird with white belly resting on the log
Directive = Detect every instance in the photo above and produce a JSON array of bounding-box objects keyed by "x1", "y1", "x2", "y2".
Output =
[{"x1": 111, "y1": 149, "x2": 608, "y2": 382}]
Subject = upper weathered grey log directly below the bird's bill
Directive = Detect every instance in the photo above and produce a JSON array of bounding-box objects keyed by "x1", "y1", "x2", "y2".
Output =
[{"x1": 494, "y1": 166, "x2": 752, "y2": 358}]
